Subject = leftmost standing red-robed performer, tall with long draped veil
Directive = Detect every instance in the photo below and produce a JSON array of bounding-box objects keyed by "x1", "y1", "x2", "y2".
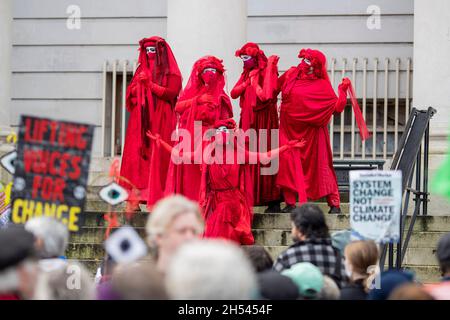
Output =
[{"x1": 120, "y1": 36, "x2": 181, "y2": 209}]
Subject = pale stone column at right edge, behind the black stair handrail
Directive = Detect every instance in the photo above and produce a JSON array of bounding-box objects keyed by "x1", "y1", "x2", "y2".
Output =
[{"x1": 413, "y1": 0, "x2": 450, "y2": 214}]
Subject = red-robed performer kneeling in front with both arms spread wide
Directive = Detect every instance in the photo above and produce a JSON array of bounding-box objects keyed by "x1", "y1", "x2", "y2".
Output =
[{"x1": 149, "y1": 119, "x2": 304, "y2": 245}]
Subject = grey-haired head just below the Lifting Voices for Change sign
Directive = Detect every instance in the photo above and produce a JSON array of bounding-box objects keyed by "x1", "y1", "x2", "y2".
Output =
[{"x1": 25, "y1": 217, "x2": 69, "y2": 259}]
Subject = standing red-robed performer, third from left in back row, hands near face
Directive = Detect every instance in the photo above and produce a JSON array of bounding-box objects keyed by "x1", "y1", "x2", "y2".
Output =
[{"x1": 230, "y1": 42, "x2": 280, "y2": 212}]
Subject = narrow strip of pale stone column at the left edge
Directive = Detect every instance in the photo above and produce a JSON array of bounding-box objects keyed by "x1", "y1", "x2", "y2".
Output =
[{"x1": 0, "y1": 0, "x2": 12, "y2": 136}]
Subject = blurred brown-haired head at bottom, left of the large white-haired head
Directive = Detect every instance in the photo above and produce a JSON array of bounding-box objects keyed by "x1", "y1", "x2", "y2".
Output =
[{"x1": 111, "y1": 261, "x2": 167, "y2": 300}]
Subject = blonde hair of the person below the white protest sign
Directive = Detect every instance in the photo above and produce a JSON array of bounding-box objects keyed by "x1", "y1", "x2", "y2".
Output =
[{"x1": 344, "y1": 240, "x2": 378, "y2": 290}]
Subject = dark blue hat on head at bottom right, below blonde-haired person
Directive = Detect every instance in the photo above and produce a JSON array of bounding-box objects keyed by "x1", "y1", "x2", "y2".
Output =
[{"x1": 368, "y1": 270, "x2": 414, "y2": 300}]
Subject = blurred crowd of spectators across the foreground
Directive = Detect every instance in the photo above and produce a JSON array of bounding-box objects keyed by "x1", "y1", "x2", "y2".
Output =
[{"x1": 0, "y1": 195, "x2": 450, "y2": 300}]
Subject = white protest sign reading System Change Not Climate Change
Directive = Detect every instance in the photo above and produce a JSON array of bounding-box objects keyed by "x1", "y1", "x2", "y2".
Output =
[{"x1": 350, "y1": 170, "x2": 402, "y2": 243}]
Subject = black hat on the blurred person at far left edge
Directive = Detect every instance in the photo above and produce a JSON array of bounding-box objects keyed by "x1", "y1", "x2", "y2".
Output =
[{"x1": 0, "y1": 225, "x2": 35, "y2": 271}]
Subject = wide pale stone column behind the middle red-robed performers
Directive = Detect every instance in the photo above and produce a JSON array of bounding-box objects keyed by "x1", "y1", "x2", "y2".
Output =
[{"x1": 167, "y1": 0, "x2": 247, "y2": 119}]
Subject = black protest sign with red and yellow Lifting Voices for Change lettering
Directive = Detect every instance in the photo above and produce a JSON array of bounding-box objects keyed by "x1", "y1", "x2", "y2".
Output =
[{"x1": 11, "y1": 116, "x2": 94, "y2": 231}]
